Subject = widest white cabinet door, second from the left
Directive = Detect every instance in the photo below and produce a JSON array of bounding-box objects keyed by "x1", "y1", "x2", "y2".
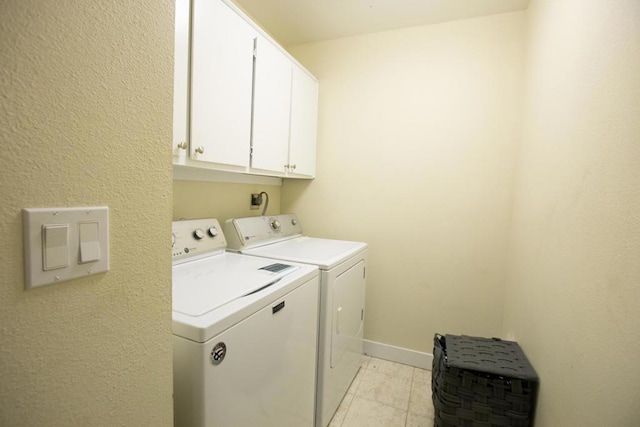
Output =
[{"x1": 190, "y1": 0, "x2": 256, "y2": 167}]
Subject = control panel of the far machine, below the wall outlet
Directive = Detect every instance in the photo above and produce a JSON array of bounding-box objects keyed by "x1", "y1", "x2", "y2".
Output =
[{"x1": 224, "y1": 214, "x2": 302, "y2": 250}]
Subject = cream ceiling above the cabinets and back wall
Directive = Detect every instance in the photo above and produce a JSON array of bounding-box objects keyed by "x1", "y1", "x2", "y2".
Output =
[{"x1": 233, "y1": 0, "x2": 530, "y2": 46}]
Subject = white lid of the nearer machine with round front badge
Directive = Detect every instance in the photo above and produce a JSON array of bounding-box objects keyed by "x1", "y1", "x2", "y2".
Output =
[{"x1": 173, "y1": 253, "x2": 300, "y2": 317}]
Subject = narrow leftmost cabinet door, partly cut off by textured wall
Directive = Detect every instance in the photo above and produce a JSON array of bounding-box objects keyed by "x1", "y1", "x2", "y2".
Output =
[{"x1": 171, "y1": 0, "x2": 189, "y2": 159}]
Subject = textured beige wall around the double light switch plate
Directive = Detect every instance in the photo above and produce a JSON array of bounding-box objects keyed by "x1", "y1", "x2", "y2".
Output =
[{"x1": 0, "y1": 0, "x2": 174, "y2": 426}]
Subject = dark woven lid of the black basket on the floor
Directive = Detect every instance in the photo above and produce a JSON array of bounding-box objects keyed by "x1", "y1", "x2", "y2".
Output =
[{"x1": 445, "y1": 335, "x2": 538, "y2": 381}]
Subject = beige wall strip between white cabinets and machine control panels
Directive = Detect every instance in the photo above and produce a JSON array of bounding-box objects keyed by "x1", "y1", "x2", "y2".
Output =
[{"x1": 173, "y1": 180, "x2": 282, "y2": 224}]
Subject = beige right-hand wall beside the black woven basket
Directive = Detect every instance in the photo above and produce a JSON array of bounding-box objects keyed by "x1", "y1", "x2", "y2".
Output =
[{"x1": 504, "y1": 0, "x2": 640, "y2": 427}]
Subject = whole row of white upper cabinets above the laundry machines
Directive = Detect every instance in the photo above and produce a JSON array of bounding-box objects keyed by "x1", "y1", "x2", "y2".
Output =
[{"x1": 171, "y1": 0, "x2": 318, "y2": 180}]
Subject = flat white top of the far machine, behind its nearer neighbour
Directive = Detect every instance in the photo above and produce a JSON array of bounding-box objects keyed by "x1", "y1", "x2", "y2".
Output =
[{"x1": 242, "y1": 236, "x2": 367, "y2": 270}]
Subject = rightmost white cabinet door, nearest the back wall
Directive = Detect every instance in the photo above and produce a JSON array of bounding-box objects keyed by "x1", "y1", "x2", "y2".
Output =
[{"x1": 288, "y1": 66, "x2": 318, "y2": 177}]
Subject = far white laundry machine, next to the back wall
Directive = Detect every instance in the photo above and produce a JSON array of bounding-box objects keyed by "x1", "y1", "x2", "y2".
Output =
[{"x1": 224, "y1": 214, "x2": 367, "y2": 427}]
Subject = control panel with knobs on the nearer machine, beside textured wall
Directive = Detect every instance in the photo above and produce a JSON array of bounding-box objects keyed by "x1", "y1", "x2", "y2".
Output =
[{"x1": 171, "y1": 218, "x2": 227, "y2": 262}]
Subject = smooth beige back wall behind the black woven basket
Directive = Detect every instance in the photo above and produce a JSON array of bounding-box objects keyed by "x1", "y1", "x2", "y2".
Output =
[{"x1": 282, "y1": 12, "x2": 524, "y2": 353}]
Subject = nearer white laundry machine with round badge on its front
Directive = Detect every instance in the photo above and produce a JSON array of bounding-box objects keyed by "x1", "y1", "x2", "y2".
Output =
[{"x1": 172, "y1": 219, "x2": 319, "y2": 427}]
